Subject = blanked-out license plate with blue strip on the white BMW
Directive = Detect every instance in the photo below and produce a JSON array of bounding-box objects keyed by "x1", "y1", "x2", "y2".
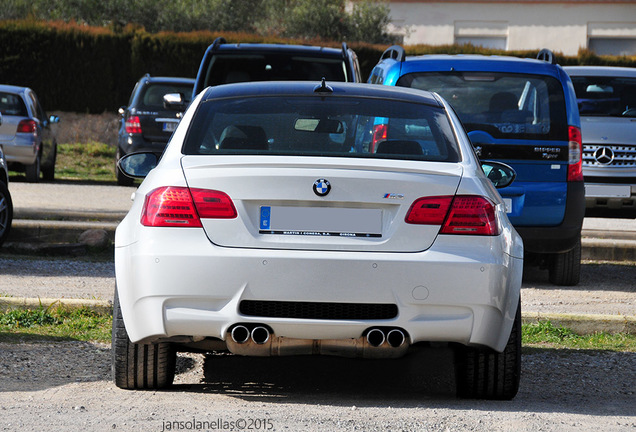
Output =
[{"x1": 259, "y1": 206, "x2": 382, "y2": 237}]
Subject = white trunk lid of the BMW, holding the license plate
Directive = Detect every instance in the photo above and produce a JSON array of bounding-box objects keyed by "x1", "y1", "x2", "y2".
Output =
[{"x1": 182, "y1": 156, "x2": 462, "y2": 252}]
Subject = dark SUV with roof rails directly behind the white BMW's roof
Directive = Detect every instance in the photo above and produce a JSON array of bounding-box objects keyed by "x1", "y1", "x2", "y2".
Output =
[{"x1": 194, "y1": 37, "x2": 362, "y2": 95}]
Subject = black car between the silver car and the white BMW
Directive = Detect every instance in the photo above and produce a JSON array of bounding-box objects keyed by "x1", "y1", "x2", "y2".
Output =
[{"x1": 115, "y1": 74, "x2": 194, "y2": 186}]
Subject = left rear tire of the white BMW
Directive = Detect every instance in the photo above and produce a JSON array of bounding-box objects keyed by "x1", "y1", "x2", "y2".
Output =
[{"x1": 112, "y1": 289, "x2": 177, "y2": 390}]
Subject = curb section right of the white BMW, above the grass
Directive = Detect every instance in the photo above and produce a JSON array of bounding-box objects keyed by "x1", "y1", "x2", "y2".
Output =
[{"x1": 521, "y1": 312, "x2": 636, "y2": 335}]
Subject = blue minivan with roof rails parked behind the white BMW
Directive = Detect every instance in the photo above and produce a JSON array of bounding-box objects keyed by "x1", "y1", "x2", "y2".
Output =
[{"x1": 369, "y1": 46, "x2": 585, "y2": 285}]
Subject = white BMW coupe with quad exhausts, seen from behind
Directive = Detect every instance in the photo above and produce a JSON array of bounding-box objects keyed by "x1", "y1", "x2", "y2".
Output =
[{"x1": 113, "y1": 81, "x2": 523, "y2": 399}]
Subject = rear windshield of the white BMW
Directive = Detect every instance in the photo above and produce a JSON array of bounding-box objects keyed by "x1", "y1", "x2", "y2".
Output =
[{"x1": 183, "y1": 96, "x2": 459, "y2": 162}]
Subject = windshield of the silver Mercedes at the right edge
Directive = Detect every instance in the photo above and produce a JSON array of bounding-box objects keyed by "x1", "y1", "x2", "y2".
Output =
[{"x1": 571, "y1": 76, "x2": 636, "y2": 117}]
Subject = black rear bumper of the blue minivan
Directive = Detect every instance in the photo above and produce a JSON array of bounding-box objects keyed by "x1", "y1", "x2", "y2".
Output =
[{"x1": 515, "y1": 182, "x2": 585, "y2": 253}]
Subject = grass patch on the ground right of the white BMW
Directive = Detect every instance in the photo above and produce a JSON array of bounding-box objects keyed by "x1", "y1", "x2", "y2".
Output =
[{"x1": 522, "y1": 321, "x2": 636, "y2": 352}]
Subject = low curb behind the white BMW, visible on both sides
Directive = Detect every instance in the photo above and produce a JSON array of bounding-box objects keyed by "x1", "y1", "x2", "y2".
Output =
[{"x1": 0, "y1": 297, "x2": 636, "y2": 335}]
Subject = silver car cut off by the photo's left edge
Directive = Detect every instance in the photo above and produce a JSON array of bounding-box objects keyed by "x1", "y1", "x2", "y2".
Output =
[{"x1": 0, "y1": 85, "x2": 60, "y2": 182}]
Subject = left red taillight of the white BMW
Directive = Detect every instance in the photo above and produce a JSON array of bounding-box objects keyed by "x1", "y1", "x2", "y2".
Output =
[{"x1": 141, "y1": 186, "x2": 237, "y2": 227}]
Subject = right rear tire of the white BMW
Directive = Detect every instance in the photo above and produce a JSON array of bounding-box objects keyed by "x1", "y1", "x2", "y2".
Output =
[{"x1": 455, "y1": 302, "x2": 521, "y2": 400}]
